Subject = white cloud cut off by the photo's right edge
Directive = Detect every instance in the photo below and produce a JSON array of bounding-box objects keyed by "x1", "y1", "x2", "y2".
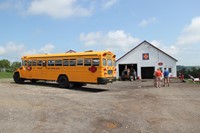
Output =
[{"x1": 177, "y1": 17, "x2": 200, "y2": 45}]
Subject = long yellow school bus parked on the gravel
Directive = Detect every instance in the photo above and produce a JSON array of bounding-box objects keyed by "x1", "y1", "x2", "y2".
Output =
[{"x1": 13, "y1": 51, "x2": 116, "y2": 88}]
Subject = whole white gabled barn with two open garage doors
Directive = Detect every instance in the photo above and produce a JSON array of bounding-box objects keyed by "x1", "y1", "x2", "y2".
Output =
[{"x1": 116, "y1": 41, "x2": 177, "y2": 79}]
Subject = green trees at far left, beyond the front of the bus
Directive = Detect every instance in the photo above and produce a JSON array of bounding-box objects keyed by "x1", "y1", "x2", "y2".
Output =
[{"x1": 0, "y1": 59, "x2": 21, "y2": 72}]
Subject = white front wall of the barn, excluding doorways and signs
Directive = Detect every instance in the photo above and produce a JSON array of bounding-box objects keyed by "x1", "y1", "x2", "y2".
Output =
[{"x1": 116, "y1": 41, "x2": 177, "y2": 78}]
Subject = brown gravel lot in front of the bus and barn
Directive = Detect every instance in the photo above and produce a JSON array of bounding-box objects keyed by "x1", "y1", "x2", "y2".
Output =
[{"x1": 0, "y1": 79, "x2": 200, "y2": 133}]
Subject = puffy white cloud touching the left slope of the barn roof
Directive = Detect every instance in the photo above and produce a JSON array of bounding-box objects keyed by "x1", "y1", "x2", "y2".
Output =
[{"x1": 80, "y1": 30, "x2": 140, "y2": 53}]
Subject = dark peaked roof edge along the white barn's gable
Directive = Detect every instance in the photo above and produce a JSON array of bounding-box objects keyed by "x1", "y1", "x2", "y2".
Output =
[{"x1": 117, "y1": 40, "x2": 178, "y2": 62}]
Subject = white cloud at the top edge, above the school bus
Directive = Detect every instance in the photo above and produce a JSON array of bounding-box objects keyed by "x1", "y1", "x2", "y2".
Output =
[{"x1": 28, "y1": 0, "x2": 92, "y2": 18}]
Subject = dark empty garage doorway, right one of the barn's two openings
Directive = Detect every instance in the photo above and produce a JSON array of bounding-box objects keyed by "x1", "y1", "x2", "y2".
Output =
[{"x1": 141, "y1": 67, "x2": 155, "y2": 79}]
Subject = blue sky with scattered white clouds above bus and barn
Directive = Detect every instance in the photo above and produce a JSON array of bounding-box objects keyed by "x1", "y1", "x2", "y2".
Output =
[{"x1": 0, "y1": 0, "x2": 200, "y2": 66}]
